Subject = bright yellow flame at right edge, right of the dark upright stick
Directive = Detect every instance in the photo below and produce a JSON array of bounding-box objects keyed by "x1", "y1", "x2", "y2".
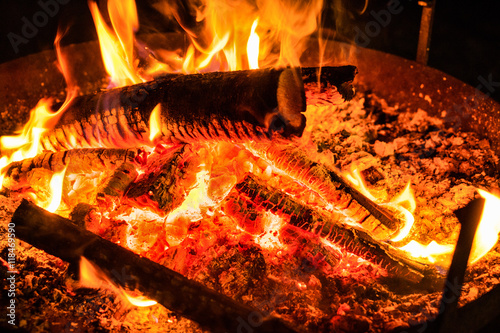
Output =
[{"x1": 469, "y1": 189, "x2": 500, "y2": 263}]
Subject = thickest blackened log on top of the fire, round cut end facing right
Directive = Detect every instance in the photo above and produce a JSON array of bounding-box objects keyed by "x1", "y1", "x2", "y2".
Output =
[{"x1": 42, "y1": 69, "x2": 306, "y2": 150}]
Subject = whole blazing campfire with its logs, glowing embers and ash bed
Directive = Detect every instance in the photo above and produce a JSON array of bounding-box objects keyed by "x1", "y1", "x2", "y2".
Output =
[{"x1": 0, "y1": 0, "x2": 500, "y2": 332}]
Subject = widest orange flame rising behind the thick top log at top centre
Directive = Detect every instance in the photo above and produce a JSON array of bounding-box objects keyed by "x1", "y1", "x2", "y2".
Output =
[{"x1": 155, "y1": 0, "x2": 323, "y2": 73}]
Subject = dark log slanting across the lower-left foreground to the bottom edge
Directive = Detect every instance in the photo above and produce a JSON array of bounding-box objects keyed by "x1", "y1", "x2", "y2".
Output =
[{"x1": 12, "y1": 200, "x2": 295, "y2": 332}]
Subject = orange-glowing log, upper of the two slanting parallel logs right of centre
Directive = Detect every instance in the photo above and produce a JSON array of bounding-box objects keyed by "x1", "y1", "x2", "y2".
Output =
[{"x1": 247, "y1": 143, "x2": 401, "y2": 240}]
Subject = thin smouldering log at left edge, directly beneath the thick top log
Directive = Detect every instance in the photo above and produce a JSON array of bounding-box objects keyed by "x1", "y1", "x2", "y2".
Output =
[{"x1": 3, "y1": 148, "x2": 139, "y2": 188}]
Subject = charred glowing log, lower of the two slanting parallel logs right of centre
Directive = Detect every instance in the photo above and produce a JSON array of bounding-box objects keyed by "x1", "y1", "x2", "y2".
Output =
[{"x1": 229, "y1": 175, "x2": 429, "y2": 282}]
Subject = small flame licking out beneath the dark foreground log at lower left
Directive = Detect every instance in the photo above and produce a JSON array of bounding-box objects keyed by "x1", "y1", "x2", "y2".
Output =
[{"x1": 79, "y1": 257, "x2": 157, "y2": 307}]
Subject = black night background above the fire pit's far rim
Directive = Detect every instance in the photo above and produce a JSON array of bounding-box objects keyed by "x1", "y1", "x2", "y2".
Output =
[{"x1": 0, "y1": 0, "x2": 500, "y2": 101}]
